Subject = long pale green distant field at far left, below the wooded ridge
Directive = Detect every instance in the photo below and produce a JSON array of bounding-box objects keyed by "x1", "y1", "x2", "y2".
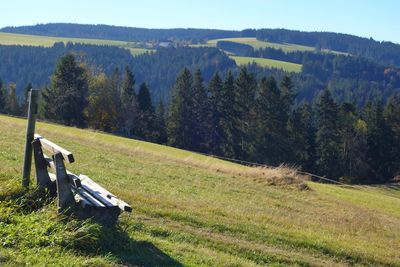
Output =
[{"x1": 0, "y1": 32, "x2": 151, "y2": 55}]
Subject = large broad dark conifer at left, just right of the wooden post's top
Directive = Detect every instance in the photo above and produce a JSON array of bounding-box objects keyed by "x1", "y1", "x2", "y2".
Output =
[{"x1": 43, "y1": 54, "x2": 88, "y2": 127}]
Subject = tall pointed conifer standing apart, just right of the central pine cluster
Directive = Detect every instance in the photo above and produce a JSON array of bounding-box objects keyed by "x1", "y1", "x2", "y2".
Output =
[{"x1": 316, "y1": 90, "x2": 341, "y2": 180}]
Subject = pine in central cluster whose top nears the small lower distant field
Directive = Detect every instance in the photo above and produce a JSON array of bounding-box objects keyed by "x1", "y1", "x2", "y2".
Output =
[{"x1": 232, "y1": 68, "x2": 257, "y2": 159}]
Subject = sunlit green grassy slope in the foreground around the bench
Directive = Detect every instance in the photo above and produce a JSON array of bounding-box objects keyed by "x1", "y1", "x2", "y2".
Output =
[{"x1": 0, "y1": 115, "x2": 400, "y2": 266}]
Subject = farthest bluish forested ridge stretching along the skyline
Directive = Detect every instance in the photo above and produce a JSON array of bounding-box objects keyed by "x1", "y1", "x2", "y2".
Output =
[{"x1": 0, "y1": 23, "x2": 400, "y2": 67}]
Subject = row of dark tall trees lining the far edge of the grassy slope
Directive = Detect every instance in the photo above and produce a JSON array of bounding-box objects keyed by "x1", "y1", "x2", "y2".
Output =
[{"x1": 0, "y1": 54, "x2": 400, "y2": 184}]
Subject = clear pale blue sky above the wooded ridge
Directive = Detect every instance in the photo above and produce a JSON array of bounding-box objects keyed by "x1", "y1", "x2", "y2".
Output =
[{"x1": 0, "y1": 0, "x2": 400, "y2": 43}]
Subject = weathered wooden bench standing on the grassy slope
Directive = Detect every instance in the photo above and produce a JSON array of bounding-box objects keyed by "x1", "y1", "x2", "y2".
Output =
[{"x1": 32, "y1": 134, "x2": 132, "y2": 220}]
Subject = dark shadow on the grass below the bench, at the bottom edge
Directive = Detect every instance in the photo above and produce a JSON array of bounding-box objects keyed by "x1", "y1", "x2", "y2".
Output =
[{"x1": 86, "y1": 224, "x2": 183, "y2": 266}]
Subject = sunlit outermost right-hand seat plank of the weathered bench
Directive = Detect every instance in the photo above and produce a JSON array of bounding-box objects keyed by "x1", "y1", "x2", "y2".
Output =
[{"x1": 79, "y1": 174, "x2": 132, "y2": 212}]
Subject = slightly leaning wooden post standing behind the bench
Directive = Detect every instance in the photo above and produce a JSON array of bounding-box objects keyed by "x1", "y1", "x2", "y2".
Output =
[{"x1": 22, "y1": 90, "x2": 39, "y2": 188}]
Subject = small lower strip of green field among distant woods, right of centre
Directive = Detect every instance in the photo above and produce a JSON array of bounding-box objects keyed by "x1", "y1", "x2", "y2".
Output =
[{"x1": 229, "y1": 56, "x2": 301, "y2": 72}]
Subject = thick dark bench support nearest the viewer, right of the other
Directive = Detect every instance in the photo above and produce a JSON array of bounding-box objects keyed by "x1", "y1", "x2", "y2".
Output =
[{"x1": 54, "y1": 153, "x2": 75, "y2": 213}]
